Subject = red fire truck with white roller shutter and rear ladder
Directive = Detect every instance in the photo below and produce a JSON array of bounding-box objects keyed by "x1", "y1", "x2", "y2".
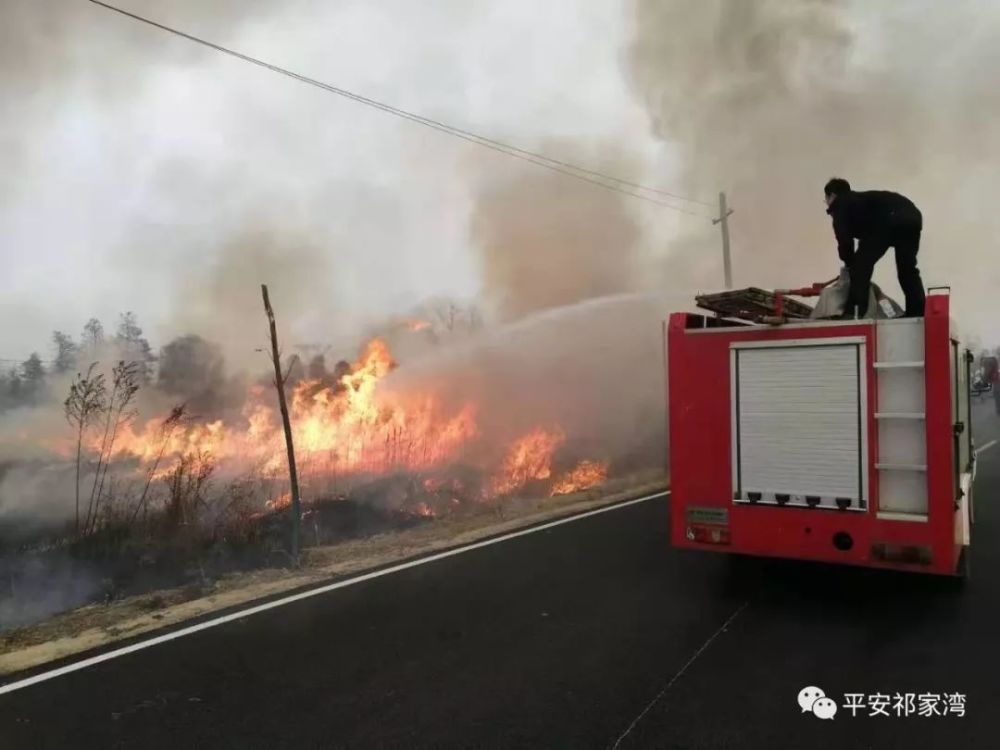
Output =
[{"x1": 665, "y1": 285, "x2": 976, "y2": 575}]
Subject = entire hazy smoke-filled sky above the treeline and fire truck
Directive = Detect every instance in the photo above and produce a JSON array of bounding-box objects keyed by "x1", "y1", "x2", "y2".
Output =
[{"x1": 0, "y1": 0, "x2": 1000, "y2": 366}]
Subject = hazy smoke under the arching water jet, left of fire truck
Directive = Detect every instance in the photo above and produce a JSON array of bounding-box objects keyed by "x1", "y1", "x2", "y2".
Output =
[{"x1": 389, "y1": 295, "x2": 666, "y2": 468}]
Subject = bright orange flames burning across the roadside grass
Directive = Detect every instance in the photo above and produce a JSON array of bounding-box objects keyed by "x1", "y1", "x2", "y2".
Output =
[{"x1": 62, "y1": 338, "x2": 607, "y2": 515}]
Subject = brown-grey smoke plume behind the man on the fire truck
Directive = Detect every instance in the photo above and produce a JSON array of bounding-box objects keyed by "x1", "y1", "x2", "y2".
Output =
[{"x1": 627, "y1": 0, "x2": 1000, "y2": 338}]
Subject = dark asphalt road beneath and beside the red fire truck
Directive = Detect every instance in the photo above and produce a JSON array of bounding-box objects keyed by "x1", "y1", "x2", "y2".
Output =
[{"x1": 0, "y1": 404, "x2": 1000, "y2": 750}]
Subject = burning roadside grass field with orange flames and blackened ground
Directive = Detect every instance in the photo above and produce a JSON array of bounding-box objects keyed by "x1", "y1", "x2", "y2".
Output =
[{"x1": 0, "y1": 329, "x2": 632, "y2": 627}]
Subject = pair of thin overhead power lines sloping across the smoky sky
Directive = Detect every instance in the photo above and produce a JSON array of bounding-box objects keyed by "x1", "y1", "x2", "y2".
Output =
[{"x1": 89, "y1": 0, "x2": 713, "y2": 218}]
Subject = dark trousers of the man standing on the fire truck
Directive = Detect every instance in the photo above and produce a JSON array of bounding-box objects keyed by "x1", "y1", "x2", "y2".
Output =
[{"x1": 845, "y1": 223, "x2": 924, "y2": 318}]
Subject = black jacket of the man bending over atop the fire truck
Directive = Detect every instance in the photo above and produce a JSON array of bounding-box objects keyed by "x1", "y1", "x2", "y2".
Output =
[{"x1": 826, "y1": 190, "x2": 923, "y2": 263}]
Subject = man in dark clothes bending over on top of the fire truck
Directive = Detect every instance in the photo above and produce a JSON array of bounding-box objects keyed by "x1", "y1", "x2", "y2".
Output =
[{"x1": 823, "y1": 177, "x2": 924, "y2": 318}]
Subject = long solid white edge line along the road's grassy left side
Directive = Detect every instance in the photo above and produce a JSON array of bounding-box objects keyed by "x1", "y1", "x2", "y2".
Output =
[{"x1": 0, "y1": 490, "x2": 670, "y2": 695}]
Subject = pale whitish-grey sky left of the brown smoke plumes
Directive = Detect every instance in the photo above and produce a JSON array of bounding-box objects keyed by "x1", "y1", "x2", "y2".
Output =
[{"x1": 0, "y1": 0, "x2": 673, "y2": 364}]
